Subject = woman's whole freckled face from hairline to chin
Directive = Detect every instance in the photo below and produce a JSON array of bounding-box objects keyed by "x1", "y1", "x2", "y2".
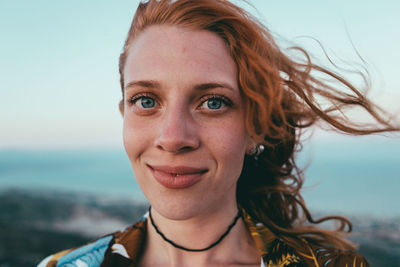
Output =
[{"x1": 121, "y1": 25, "x2": 249, "y2": 220}]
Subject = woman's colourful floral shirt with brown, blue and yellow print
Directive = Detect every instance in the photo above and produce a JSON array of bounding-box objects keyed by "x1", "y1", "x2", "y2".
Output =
[{"x1": 38, "y1": 210, "x2": 369, "y2": 267}]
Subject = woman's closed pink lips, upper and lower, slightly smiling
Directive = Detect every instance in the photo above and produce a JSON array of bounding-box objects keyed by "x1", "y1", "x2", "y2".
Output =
[{"x1": 147, "y1": 165, "x2": 207, "y2": 189}]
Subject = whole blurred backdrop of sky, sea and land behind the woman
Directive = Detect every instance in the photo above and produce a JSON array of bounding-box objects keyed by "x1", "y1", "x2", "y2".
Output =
[{"x1": 0, "y1": 0, "x2": 400, "y2": 267}]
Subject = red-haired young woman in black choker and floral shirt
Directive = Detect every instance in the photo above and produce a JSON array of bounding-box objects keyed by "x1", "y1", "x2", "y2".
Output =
[{"x1": 39, "y1": 0, "x2": 398, "y2": 266}]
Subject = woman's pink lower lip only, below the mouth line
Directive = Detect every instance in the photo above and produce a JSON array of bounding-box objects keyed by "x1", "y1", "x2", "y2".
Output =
[{"x1": 150, "y1": 167, "x2": 205, "y2": 189}]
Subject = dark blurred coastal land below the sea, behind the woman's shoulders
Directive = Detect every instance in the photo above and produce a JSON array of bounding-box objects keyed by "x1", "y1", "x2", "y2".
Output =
[{"x1": 0, "y1": 189, "x2": 400, "y2": 267}]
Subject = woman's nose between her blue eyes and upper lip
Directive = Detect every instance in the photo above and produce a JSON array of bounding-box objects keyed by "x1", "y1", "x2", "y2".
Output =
[{"x1": 155, "y1": 108, "x2": 200, "y2": 153}]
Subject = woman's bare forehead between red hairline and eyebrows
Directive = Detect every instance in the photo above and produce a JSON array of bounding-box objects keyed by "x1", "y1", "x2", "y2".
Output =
[{"x1": 124, "y1": 25, "x2": 237, "y2": 88}]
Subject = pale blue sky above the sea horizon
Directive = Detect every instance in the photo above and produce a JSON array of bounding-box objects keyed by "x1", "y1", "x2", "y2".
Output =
[{"x1": 0, "y1": 0, "x2": 400, "y2": 148}]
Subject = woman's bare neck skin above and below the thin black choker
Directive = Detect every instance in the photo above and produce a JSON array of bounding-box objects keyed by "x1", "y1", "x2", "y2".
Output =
[{"x1": 143, "y1": 206, "x2": 260, "y2": 266}]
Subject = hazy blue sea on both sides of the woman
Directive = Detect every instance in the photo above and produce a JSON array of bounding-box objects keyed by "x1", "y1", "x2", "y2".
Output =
[{"x1": 0, "y1": 137, "x2": 400, "y2": 218}]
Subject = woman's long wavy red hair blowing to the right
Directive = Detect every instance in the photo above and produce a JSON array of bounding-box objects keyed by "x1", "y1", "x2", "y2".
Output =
[{"x1": 119, "y1": 0, "x2": 399, "y2": 250}]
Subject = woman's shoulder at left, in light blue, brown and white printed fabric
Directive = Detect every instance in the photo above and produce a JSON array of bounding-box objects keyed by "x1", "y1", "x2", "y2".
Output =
[{"x1": 38, "y1": 217, "x2": 146, "y2": 267}]
